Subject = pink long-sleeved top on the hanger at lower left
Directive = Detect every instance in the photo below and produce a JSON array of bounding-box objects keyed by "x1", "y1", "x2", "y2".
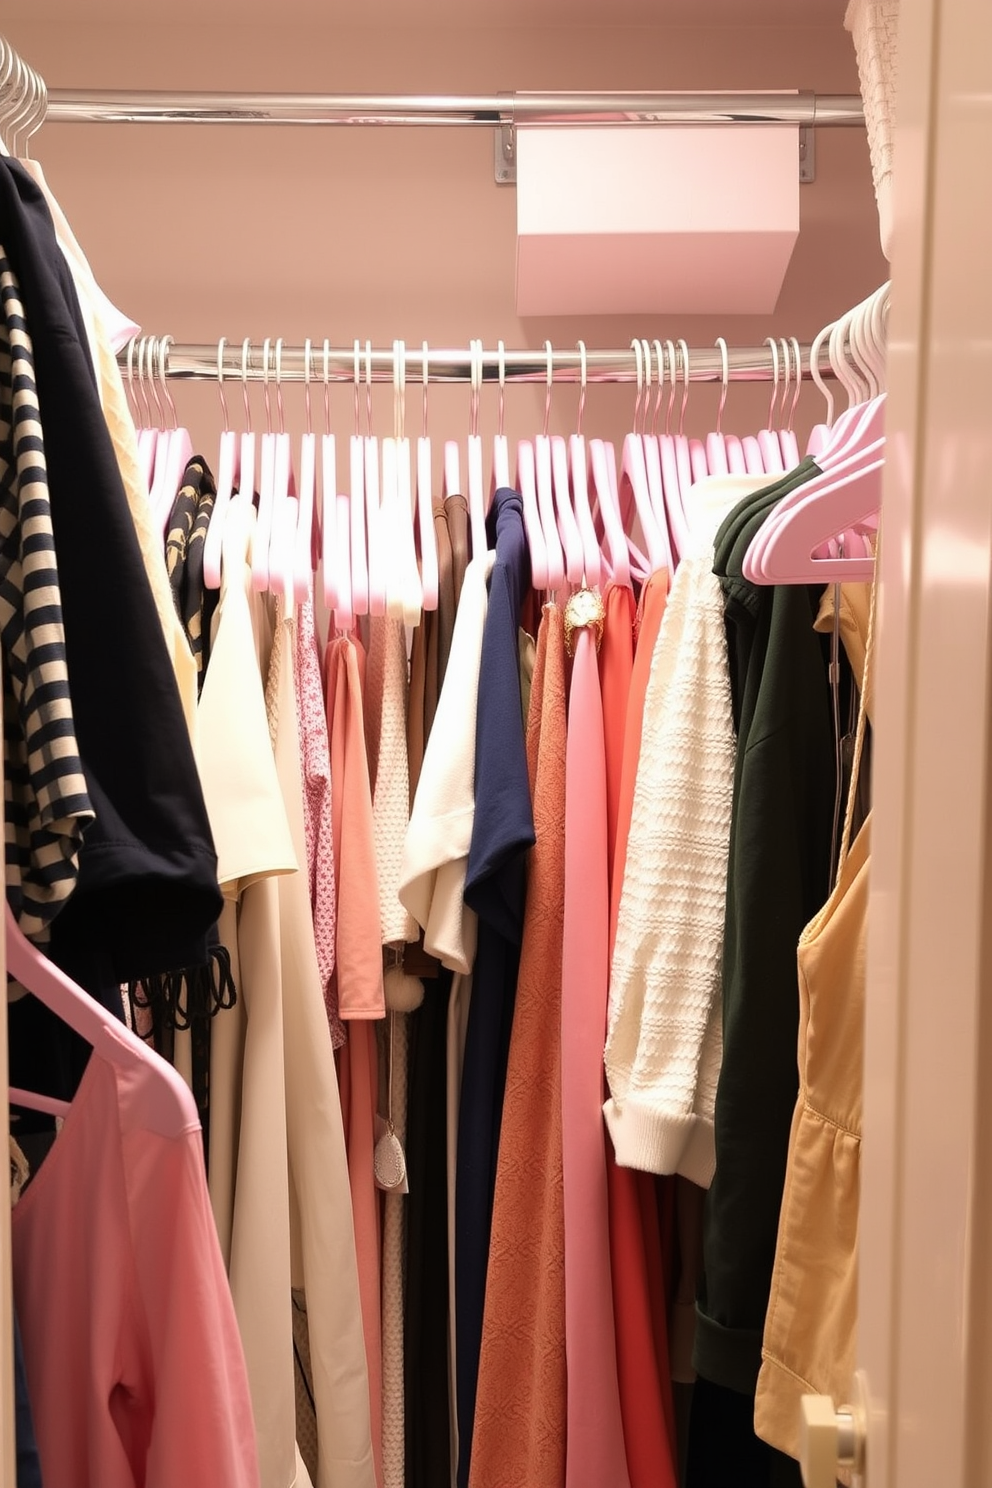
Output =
[{"x1": 10, "y1": 1034, "x2": 260, "y2": 1488}]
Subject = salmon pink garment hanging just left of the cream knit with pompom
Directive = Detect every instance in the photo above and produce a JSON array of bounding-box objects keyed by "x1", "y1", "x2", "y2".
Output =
[{"x1": 324, "y1": 635, "x2": 385, "y2": 1484}]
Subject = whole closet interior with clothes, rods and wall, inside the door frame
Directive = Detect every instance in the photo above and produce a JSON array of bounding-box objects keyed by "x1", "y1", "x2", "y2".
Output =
[{"x1": 0, "y1": 0, "x2": 891, "y2": 1488}]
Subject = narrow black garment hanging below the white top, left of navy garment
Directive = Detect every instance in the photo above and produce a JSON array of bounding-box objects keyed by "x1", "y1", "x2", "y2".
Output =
[{"x1": 403, "y1": 967, "x2": 452, "y2": 1488}]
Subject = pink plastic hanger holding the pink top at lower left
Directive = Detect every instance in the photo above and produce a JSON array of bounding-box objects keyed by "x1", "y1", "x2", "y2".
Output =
[{"x1": 4, "y1": 903, "x2": 190, "y2": 1129}]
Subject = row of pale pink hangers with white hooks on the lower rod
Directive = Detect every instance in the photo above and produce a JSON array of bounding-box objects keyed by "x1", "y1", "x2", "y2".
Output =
[{"x1": 126, "y1": 308, "x2": 888, "y2": 629}]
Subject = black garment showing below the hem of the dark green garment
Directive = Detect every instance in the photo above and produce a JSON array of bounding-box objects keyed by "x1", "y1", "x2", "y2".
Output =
[{"x1": 686, "y1": 1379, "x2": 803, "y2": 1488}]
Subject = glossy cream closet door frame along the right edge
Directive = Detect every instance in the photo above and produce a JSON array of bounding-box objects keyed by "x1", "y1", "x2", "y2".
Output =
[{"x1": 858, "y1": 0, "x2": 992, "y2": 1488}]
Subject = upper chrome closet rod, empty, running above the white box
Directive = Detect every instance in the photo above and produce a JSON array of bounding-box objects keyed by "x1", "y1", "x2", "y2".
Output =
[{"x1": 46, "y1": 88, "x2": 864, "y2": 128}]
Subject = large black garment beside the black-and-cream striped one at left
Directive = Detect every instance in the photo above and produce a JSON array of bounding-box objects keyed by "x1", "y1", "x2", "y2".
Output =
[{"x1": 0, "y1": 159, "x2": 222, "y2": 1094}]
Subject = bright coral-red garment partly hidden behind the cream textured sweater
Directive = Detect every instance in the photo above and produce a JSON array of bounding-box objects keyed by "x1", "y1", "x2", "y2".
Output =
[{"x1": 599, "y1": 574, "x2": 675, "y2": 1488}]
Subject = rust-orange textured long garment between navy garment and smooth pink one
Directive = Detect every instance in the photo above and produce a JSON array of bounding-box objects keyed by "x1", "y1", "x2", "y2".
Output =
[{"x1": 468, "y1": 604, "x2": 565, "y2": 1488}]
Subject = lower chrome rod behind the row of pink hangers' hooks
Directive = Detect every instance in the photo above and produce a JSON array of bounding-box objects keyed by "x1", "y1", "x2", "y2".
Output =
[{"x1": 117, "y1": 336, "x2": 834, "y2": 385}]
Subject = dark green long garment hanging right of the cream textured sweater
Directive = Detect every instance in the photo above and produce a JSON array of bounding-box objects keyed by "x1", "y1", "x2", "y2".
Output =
[{"x1": 693, "y1": 476, "x2": 836, "y2": 1403}]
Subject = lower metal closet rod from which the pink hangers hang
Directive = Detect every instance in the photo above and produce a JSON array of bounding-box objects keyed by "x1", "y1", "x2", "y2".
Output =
[{"x1": 126, "y1": 341, "x2": 833, "y2": 387}]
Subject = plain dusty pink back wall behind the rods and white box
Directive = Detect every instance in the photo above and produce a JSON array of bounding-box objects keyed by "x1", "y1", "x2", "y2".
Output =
[{"x1": 3, "y1": 0, "x2": 886, "y2": 458}]
